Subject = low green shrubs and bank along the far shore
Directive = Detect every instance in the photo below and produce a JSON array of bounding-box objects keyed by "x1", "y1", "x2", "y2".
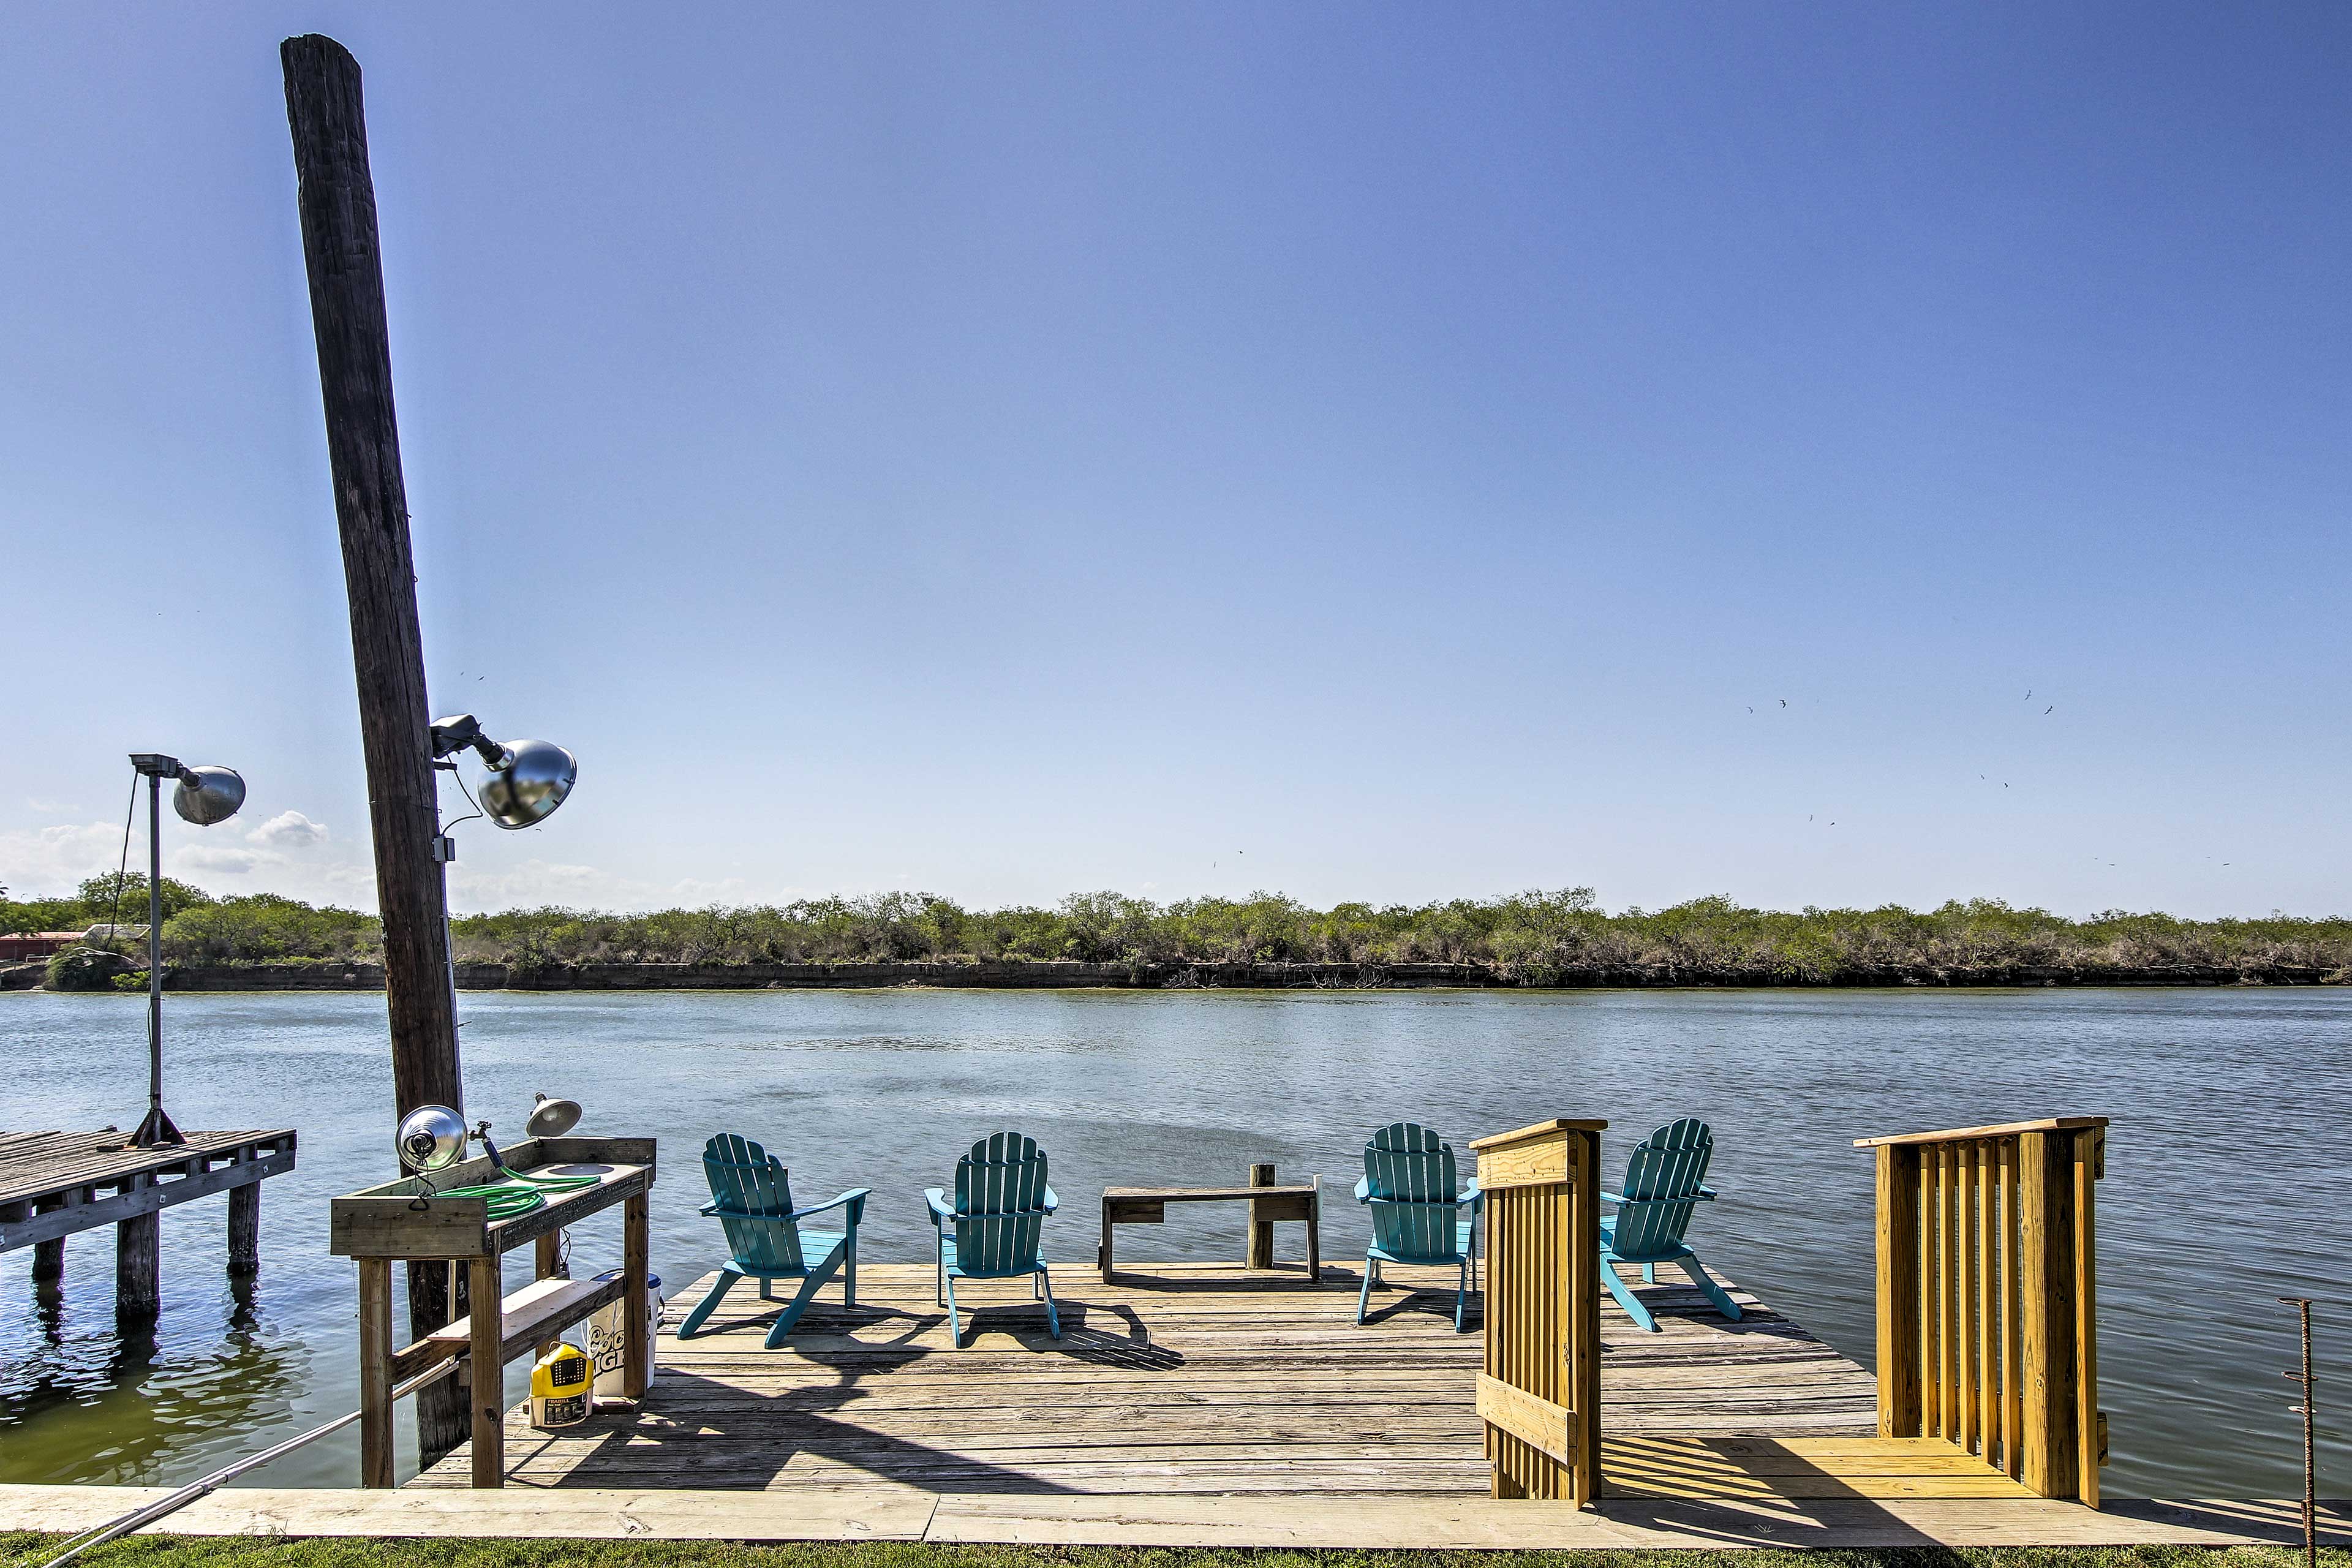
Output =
[{"x1": 0, "y1": 875, "x2": 2352, "y2": 990}]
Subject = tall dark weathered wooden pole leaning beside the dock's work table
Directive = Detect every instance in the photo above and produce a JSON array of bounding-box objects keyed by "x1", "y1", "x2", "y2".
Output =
[{"x1": 277, "y1": 33, "x2": 470, "y2": 1464}]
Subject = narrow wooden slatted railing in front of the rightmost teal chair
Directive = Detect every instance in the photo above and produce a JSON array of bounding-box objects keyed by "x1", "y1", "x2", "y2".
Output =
[{"x1": 1470, "y1": 1121, "x2": 1609, "y2": 1507}]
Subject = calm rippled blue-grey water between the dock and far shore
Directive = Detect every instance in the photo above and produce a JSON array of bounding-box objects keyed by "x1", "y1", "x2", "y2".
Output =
[{"x1": 0, "y1": 990, "x2": 2352, "y2": 1498}]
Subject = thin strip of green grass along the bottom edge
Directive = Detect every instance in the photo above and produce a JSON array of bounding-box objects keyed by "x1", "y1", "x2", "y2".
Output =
[{"x1": 0, "y1": 1532, "x2": 2352, "y2": 1568}]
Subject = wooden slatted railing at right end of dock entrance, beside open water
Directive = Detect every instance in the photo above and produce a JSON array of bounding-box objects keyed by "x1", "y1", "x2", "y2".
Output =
[{"x1": 1856, "y1": 1117, "x2": 2108, "y2": 1507}]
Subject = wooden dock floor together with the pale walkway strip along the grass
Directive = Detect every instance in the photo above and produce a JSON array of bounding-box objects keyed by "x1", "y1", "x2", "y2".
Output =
[{"x1": 0, "y1": 1265, "x2": 2352, "y2": 1549}]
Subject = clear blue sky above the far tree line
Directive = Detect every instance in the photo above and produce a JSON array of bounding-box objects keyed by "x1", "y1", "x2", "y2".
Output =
[{"x1": 0, "y1": 2, "x2": 2352, "y2": 914}]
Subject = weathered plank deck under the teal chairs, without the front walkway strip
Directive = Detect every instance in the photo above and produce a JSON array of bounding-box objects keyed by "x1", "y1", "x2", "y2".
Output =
[{"x1": 409, "y1": 1262, "x2": 2030, "y2": 1502}]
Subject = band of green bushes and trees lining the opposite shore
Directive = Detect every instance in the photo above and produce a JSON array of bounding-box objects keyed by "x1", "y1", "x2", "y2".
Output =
[{"x1": 0, "y1": 872, "x2": 2352, "y2": 985}]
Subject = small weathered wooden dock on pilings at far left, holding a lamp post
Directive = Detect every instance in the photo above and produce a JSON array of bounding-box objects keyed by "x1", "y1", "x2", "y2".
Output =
[{"x1": 0, "y1": 1126, "x2": 294, "y2": 1316}]
